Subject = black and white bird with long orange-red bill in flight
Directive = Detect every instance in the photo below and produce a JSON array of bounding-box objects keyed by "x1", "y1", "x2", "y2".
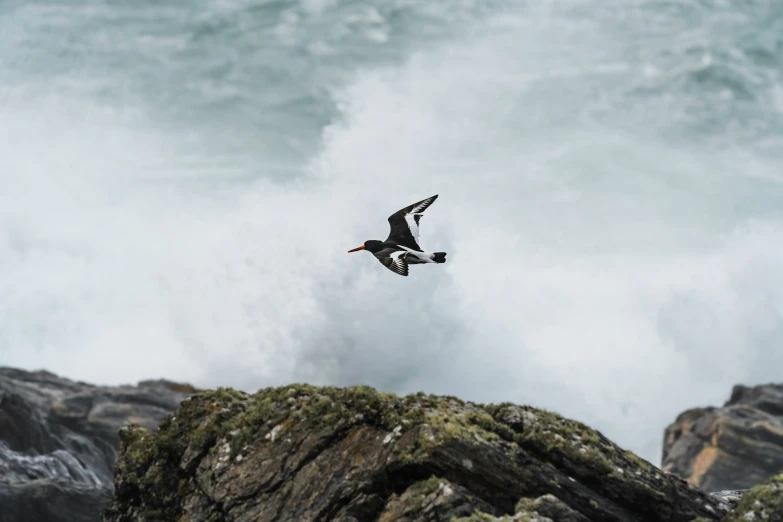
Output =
[{"x1": 348, "y1": 194, "x2": 446, "y2": 276}]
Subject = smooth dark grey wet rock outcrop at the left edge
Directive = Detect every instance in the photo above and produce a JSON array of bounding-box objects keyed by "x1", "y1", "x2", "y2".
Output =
[{"x1": 0, "y1": 368, "x2": 196, "y2": 522}]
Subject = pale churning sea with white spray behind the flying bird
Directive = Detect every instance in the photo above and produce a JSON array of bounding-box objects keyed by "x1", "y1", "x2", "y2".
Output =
[{"x1": 0, "y1": 0, "x2": 783, "y2": 464}]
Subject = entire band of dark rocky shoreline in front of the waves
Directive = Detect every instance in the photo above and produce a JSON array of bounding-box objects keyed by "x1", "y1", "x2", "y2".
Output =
[{"x1": 0, "y1": 368, "x2": 783, "y2": 522}]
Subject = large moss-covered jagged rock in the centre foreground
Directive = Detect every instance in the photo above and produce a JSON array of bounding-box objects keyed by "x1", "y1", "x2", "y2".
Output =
[{"x1": 104, "y1": 385, "x2": 728, "y2": 522}]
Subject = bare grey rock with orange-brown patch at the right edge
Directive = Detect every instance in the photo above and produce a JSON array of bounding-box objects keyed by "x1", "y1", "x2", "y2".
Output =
[{"x1": 662, "y1": 384, "x2": 783, "y2": 491}]
